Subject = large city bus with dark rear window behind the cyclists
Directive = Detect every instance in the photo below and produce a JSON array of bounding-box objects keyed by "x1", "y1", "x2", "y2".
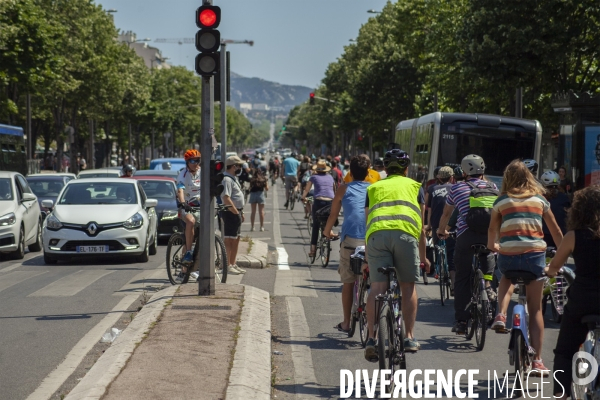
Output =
[{"x1": 394, "y1": 112, "x2": 542, "y2": 187}]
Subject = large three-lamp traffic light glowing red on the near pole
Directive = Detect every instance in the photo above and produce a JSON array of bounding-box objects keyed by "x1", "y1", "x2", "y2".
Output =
[{"x1": 196, "y1": 5, "x2": 221, "y2": 77}]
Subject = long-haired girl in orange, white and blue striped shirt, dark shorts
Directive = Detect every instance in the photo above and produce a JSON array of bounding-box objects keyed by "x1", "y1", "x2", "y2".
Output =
[{"x1": 488, "y1": 160, "x2": 562, "y2": 376}]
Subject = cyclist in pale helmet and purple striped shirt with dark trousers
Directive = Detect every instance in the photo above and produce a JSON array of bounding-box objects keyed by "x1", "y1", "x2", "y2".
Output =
[{"x1": 437, "y1": 154, "x2": 497, "y2": 335}]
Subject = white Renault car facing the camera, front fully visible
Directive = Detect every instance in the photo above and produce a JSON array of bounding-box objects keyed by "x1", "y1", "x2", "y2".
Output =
[{"x1": 42, "y1": 178, "x2": 158, "y2": 264}]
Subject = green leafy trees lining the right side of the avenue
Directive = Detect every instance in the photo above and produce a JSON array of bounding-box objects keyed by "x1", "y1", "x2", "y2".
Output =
[{"x1": 287, "y1": 0, "x2": 600, "y2": 153}]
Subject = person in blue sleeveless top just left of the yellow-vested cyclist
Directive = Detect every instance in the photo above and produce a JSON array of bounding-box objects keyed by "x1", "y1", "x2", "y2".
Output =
[{"x1": 323, "y1": 156, "x2": 370, "y2": 333}]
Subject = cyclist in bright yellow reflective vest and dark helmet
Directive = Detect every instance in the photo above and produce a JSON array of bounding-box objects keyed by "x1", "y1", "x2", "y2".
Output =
[{"x1": 360, "y1": 149, "x2": 430, "y2": 362}]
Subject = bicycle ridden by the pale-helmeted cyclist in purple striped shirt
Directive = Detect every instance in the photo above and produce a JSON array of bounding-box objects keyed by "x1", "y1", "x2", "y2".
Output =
[{"x1": 465, "y1": 244, "x2": 492, "y2": 351}]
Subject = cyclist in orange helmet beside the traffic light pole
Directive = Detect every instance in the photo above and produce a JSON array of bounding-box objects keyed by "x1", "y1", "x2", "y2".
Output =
[{"x1": 177, "y1": 149, "x2": 200, "y2": 272}]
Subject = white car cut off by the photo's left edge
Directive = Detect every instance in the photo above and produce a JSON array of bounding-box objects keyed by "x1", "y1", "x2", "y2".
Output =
[{"x1": 0, "y1": 171, "x2": 42, "y2": 259}]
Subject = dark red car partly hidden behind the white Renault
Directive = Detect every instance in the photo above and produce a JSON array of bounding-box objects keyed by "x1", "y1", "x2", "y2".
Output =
[{"x1": 133, "y1": 176, "x2": 182, "y2": 239}]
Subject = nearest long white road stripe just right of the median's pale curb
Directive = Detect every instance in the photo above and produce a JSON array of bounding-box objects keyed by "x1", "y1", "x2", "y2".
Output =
[{"x1": 286, "y1": 297, "x2": 320, "y2": 399}]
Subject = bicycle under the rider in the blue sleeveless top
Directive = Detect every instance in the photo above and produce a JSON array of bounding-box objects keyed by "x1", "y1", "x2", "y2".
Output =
[{"x1": 348, "y1": 246, "x2": 371, "y2": 348}]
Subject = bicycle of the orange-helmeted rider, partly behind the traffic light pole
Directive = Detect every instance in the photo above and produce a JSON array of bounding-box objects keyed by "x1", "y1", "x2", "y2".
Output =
[{"x1": 166, "y1": 205, "x2": 229, "y2": 285}]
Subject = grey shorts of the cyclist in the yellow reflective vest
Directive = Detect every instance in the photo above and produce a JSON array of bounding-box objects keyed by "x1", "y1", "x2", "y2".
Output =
[{"x1": 367, "y1": 230, "x2": 421, "y2": 283}]
